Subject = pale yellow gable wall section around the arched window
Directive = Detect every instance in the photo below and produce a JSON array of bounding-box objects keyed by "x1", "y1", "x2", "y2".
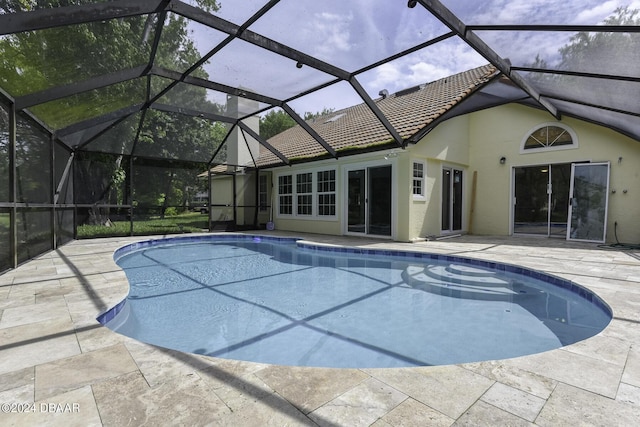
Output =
[{"x1": 469, "y1": 105, "x2": 640, "y2": 242}]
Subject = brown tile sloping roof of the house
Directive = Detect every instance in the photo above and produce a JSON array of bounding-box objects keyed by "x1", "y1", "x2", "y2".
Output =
[{"x1": 256, "y1": 65, "x2": 499, "y2": 168}]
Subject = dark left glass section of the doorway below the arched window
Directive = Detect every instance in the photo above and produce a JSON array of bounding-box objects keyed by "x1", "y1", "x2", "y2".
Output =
[{"x1": 513, "y1": 163, "x2": 571, "y2": 238}]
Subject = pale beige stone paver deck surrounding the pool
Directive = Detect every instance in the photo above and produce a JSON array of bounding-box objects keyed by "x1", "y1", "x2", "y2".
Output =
[{"x1": 0, "y1": 232, "x2": 640, "y2": 427}]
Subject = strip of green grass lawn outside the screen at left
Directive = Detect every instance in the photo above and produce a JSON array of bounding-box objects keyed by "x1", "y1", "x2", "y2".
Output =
[{"x1": 78, "y1": 212, "x2": 209, "y2": 239}]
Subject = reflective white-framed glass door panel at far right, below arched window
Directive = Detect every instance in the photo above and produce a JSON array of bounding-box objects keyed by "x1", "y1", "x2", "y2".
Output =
[{"x1": 567, "y1": 162, "x2": 609, "y2": 242}]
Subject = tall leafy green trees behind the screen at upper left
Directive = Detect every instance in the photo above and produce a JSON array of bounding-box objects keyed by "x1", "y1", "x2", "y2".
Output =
[{"x1": 0, "y1": 0, "x2": 226, "y2": 223}]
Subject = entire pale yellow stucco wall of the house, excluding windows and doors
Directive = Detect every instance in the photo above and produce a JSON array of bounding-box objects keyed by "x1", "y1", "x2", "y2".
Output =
[{"x1": 260, "y1": 104, "x2": 640, "y2": 243}]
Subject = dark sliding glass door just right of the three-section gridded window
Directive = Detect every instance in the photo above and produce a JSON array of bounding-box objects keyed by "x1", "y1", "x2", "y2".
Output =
[{"x1": 347, "y1": 166, "x2": 392, "y2": 236}]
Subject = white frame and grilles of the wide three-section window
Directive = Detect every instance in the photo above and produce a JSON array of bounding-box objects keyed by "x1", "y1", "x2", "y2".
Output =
[{"x1": 275, "y1": 167, "x2": 338, "y2": 221}]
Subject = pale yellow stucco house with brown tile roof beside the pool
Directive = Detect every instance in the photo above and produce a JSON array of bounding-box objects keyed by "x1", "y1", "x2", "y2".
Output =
[{"x1": 211, "y1": 65, "x2": 640, "y2": 242}]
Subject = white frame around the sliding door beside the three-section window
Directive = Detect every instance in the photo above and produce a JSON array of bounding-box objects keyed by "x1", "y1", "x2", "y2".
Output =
[{"x1": 341, "y1": 158, "x2": 398, "y2": 240}]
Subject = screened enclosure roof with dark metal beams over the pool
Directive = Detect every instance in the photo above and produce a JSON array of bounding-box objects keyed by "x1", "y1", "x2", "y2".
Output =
[{"x1": 0, "y1": 0, "x2": 640, "y2": 165}]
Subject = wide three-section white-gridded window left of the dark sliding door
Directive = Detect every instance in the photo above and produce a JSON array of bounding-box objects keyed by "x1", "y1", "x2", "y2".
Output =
[{"x1": 277, "y1": 169, "x2": 337, "y2": 220}]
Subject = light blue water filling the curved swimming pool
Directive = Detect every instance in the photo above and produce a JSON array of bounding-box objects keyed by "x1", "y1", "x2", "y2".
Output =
[{"x1": 99, "y1": 235, "x2": 611, "y2": 367}]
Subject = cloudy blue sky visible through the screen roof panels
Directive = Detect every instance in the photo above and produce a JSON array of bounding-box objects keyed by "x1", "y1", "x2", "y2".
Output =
[{"x1": 188, "y1": 0, "x2": 640, "y2": 115}]
